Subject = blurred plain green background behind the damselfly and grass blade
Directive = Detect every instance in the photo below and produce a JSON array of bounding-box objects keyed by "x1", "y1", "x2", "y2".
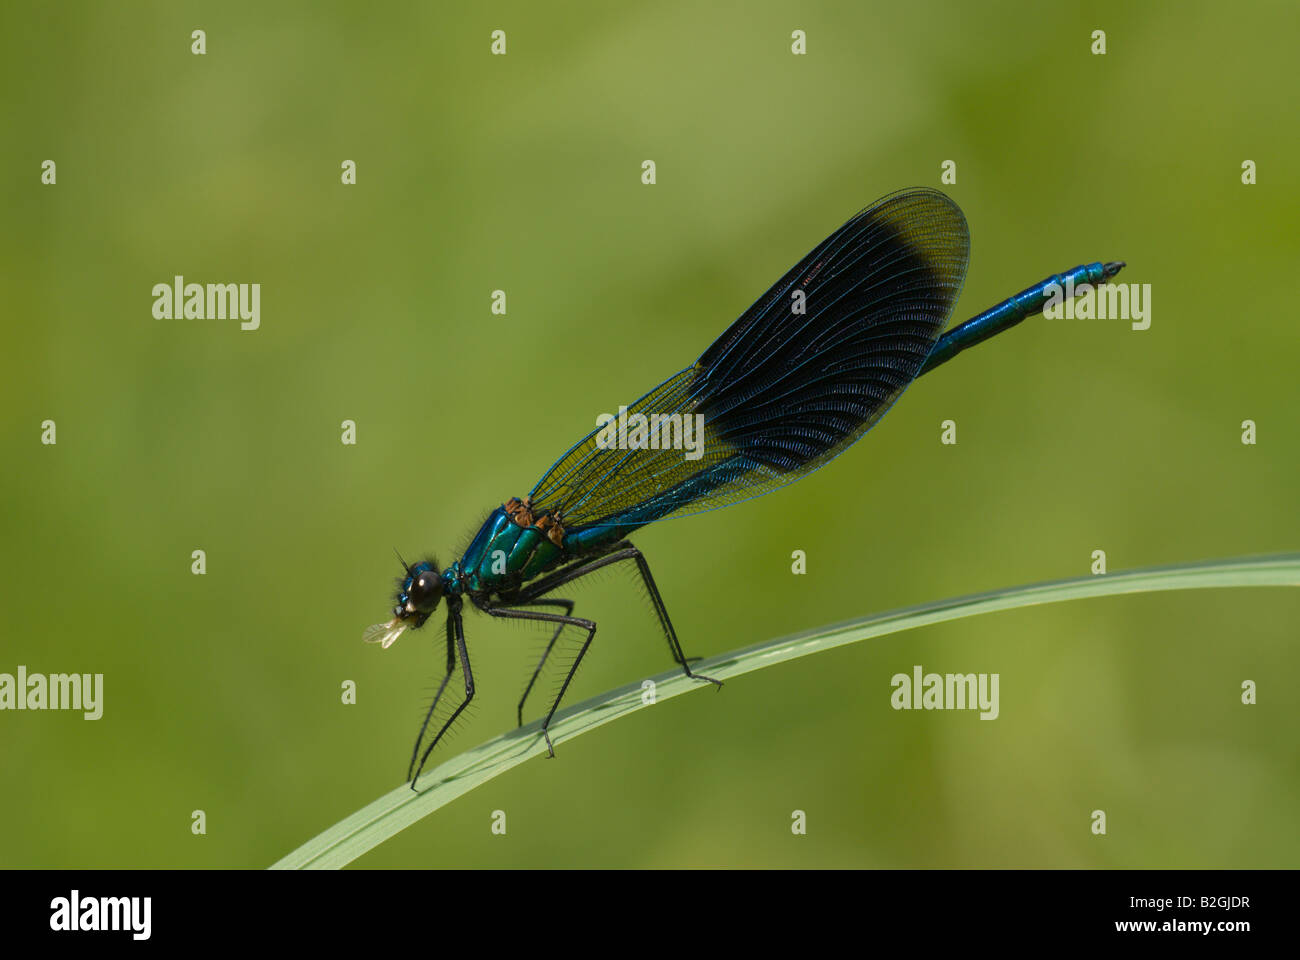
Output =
[{"x1": 0, "y1": 1, "x2": 1300, "y2": 868}]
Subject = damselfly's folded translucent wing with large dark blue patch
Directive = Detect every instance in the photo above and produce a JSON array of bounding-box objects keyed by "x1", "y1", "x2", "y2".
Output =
[{"x1": 530, "y1": 189, "x2": 970, "y2": 529}]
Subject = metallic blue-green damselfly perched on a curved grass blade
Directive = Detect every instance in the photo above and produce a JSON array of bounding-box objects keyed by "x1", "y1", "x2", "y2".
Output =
[{"x1": 364, "y1": 189, "x2": 1125, "y2": 788}]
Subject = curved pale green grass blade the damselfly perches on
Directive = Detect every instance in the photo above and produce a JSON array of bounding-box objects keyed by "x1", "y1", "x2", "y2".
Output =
[{"x1": 270, "y1": 554, "x2": 1300, "y2": 870}]
